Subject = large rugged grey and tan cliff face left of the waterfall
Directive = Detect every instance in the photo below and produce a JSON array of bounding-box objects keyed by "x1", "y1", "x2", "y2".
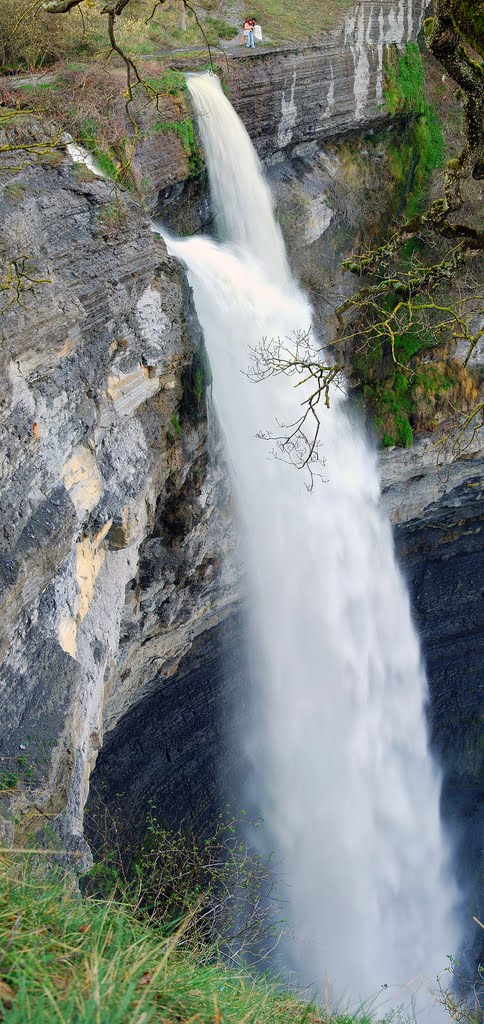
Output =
[{"x1": 0, "y1": 162, "x2": 239, "y2": 840}]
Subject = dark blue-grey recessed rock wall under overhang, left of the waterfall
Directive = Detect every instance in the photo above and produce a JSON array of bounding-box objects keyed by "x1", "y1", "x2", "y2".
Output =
[{"x1": 86, "y1": 608, "x2": 248, "y2": 850}]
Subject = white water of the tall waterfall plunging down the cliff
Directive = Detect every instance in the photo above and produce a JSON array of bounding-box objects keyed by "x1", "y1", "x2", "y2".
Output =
[{"x1": 160, "y1": 75, "x2": 455, "y2": 1021}]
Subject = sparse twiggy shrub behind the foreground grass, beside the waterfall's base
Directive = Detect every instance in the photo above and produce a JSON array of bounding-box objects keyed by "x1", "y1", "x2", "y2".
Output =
[{"x1": 83, "y1": 815, "x2": 280, "y2": 963}]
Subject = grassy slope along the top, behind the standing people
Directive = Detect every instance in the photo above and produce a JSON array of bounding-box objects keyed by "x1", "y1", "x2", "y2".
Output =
[{"x1": 0, "y1": 0, "x2": 352, "y2": 71}]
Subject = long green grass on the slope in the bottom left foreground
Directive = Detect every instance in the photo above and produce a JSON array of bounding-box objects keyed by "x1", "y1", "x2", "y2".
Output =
[{"x1": 0, "y1": 856, "x2": 382, "y2": 1024}]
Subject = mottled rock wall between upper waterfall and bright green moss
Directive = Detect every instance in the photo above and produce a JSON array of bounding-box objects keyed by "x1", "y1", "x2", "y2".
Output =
[{"x1": 267, "y1": 125, "x2": 403, "y2": 338}]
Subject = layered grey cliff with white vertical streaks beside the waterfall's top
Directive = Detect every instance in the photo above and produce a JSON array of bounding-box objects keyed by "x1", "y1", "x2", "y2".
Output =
[{"x1": 221, "y1": 0, "x2": 426, "y2": 158}]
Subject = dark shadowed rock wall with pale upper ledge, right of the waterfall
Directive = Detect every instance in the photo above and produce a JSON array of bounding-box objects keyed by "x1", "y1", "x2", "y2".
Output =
[{"x1": 381, "y1": 440, "x2": 484, "y2": 967}]
